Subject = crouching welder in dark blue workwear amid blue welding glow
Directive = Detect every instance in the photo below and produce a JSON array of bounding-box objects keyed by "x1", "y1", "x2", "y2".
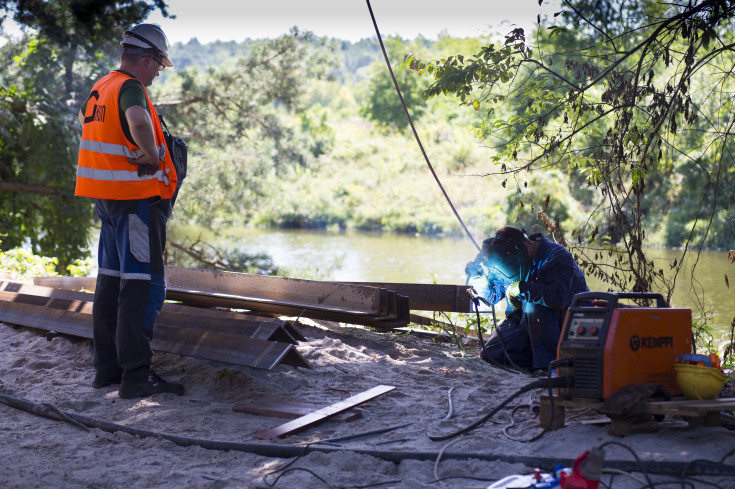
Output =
[{"x1": 465, "y1": 226, "x2": 589, "y2": 370}]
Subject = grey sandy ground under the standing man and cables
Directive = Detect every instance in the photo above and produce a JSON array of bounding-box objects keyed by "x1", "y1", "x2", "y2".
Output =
[{"x1": 0, "y1": 323, "x2": 735, "y2": 489}]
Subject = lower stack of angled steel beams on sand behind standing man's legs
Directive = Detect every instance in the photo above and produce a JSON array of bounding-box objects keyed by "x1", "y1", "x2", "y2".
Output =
[{"x1": 0, "y1": 281, "x2": 309, "y2": 369}]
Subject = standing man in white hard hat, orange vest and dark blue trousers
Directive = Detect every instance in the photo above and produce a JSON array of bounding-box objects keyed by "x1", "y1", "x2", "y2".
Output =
[{"x1": 75, "y1": 24, "x2": 184, "y2": 399}]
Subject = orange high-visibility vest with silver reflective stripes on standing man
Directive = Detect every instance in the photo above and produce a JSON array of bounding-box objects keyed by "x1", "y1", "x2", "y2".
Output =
[{"x1": 74, "y1": 71, "x2": 176, "y2": 200}]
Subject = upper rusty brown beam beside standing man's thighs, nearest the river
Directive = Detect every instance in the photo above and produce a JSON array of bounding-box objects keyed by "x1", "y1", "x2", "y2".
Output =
[{"x1": 166, "y1": 267, "x2": 381, "y2": 314}]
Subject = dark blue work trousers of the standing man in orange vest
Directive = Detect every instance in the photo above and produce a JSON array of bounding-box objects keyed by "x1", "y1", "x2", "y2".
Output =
[{"x1": 92, "y1": 197, "x2": 171, "y2": 382}]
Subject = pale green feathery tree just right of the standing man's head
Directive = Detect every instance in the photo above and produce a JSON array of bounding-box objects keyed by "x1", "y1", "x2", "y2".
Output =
[{"x1": 157, "y1": 29, "x2": 337, "y2": 225}]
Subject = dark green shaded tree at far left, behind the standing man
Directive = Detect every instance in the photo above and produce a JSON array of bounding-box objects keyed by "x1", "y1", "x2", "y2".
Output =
[{"x1": 0, "y1": 0, "x2": 167, "y2": 272}]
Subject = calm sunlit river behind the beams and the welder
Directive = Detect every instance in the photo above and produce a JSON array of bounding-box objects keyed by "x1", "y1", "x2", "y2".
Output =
[{"x1": 170, "y1": 226, "x2": 735, "y2": 343}]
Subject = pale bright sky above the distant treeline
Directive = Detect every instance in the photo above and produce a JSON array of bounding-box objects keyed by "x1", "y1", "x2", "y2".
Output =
[{"x1": 141, "y1": 0, "x2": 559, "y2": 43}]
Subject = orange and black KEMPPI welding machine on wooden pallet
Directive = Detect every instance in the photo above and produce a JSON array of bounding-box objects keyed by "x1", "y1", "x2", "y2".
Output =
[{"x1": 557, "y1": 292, "x2": 692, "y2": 400}]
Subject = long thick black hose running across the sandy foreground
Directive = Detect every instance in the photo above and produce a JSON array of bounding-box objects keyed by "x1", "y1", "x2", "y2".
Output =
[{"x1": 0, "y1": 392, "x2": 735, "y2": 476}]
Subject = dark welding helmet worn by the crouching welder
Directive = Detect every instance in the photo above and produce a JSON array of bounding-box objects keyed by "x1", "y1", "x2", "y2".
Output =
[{"x1": 482, "y1": 228, "x2": 531, "y2": 283}]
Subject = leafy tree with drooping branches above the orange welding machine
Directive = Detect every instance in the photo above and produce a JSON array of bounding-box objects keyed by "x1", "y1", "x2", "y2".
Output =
[{"x1": 406, "y1": 0, "x2": 735, "y2": 346}]
